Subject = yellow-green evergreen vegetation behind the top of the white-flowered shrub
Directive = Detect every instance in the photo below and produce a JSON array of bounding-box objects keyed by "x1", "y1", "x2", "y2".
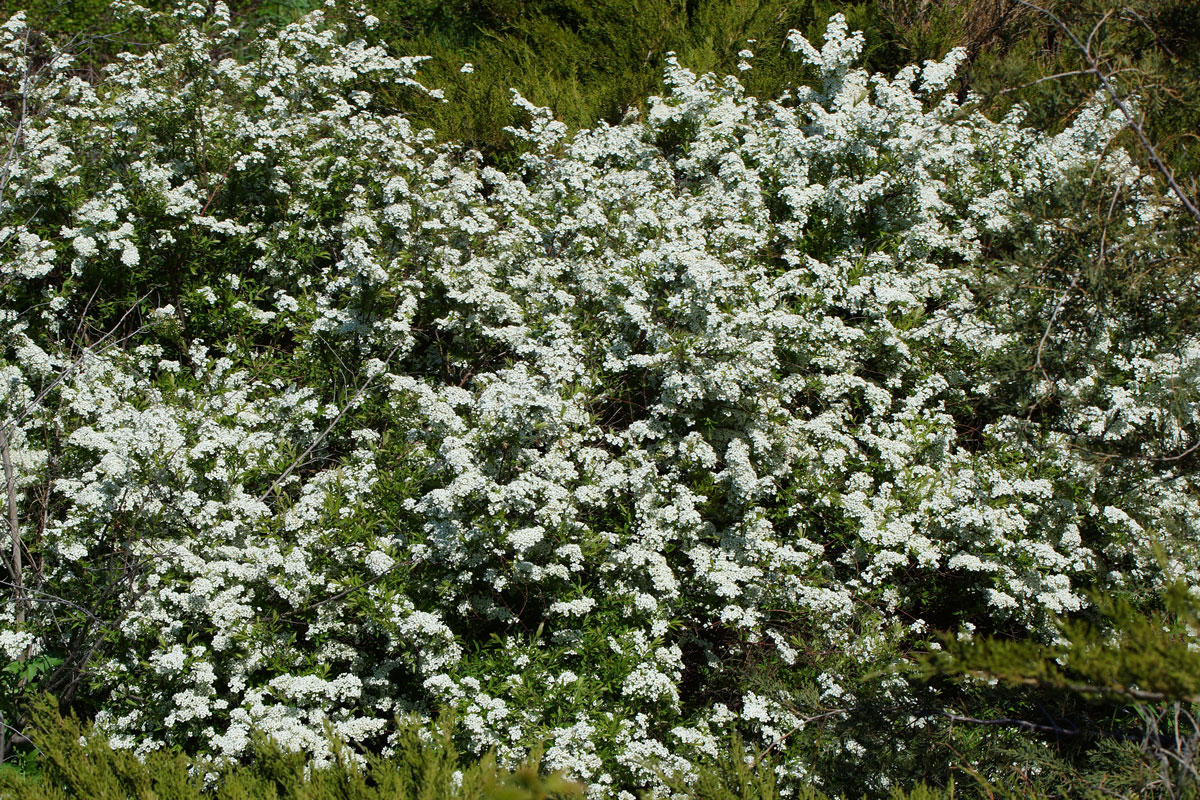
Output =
[{"x1": 23, "y1": 0, "x2": 1200, "y2": 173}]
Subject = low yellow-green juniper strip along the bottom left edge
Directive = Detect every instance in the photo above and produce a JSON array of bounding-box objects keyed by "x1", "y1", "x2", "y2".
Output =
[{"x1": 0, "y1": 697, "x2": 582, "y2": 800}]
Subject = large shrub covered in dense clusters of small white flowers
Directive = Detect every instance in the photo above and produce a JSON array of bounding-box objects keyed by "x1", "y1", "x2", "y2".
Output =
[{"x1": 0, "y1": 4, "x2": 1200, "y2": 796}]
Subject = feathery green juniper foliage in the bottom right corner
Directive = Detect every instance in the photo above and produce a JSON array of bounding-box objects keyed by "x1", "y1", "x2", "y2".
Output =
[{"x1": 920, "y1": 583, "x2": 1200, "y2": 798}]
